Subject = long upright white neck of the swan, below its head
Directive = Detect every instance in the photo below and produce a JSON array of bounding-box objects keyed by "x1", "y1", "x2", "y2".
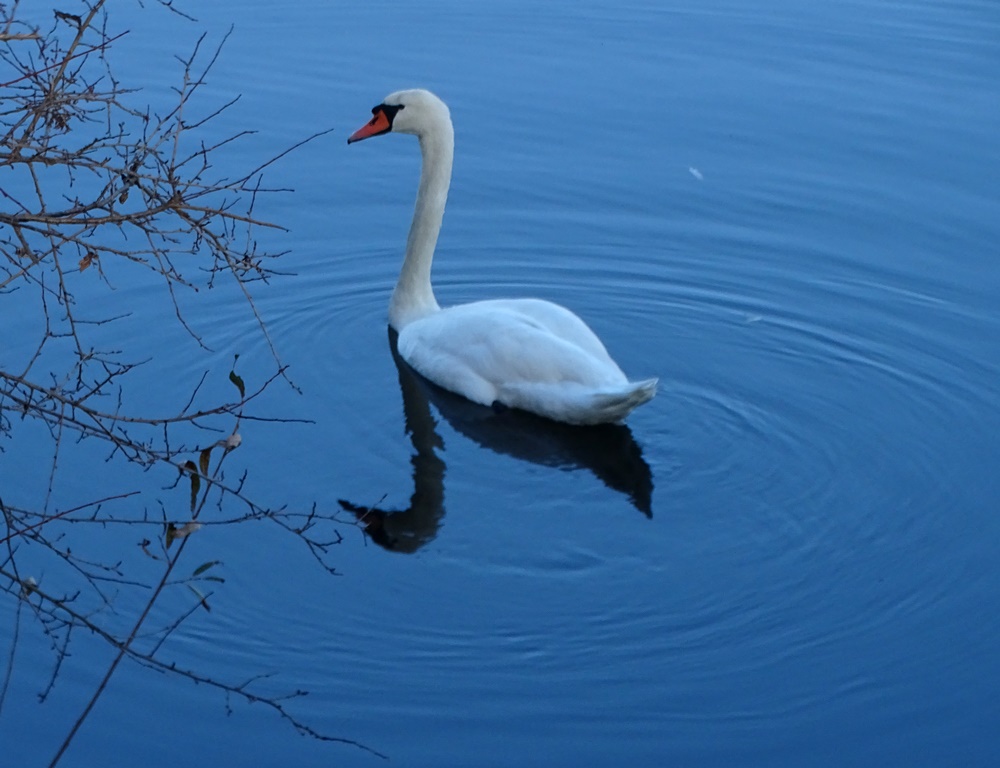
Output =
[{"x1": 389, "y1": 114, "x2": 455, "y2": 331}]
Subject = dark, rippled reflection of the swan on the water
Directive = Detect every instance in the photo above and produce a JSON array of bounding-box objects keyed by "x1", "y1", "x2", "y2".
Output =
[{"x1": 340, "y1": 328, "x2": 653, "y2": 552}]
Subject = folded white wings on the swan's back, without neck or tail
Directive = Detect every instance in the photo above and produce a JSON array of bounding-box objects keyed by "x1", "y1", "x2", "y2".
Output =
[{"x1": 398, "y1": 299, "x2": 628, "y2": 410}]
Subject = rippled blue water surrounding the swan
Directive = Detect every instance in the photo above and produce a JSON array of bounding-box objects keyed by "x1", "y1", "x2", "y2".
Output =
[{"x1": 0, "y1": 0, "x2": 1000, "y2": 766}]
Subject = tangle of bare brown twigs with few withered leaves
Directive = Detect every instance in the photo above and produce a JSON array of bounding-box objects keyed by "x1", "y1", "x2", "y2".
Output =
[{"x1": 0, "y1": 0, "x2": 379, "y2": 765}]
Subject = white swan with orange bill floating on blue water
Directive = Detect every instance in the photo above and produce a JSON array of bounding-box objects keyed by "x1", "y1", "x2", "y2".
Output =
[{"x1": 347, "y1": 89, "x2": 657, "y2": 424}]
